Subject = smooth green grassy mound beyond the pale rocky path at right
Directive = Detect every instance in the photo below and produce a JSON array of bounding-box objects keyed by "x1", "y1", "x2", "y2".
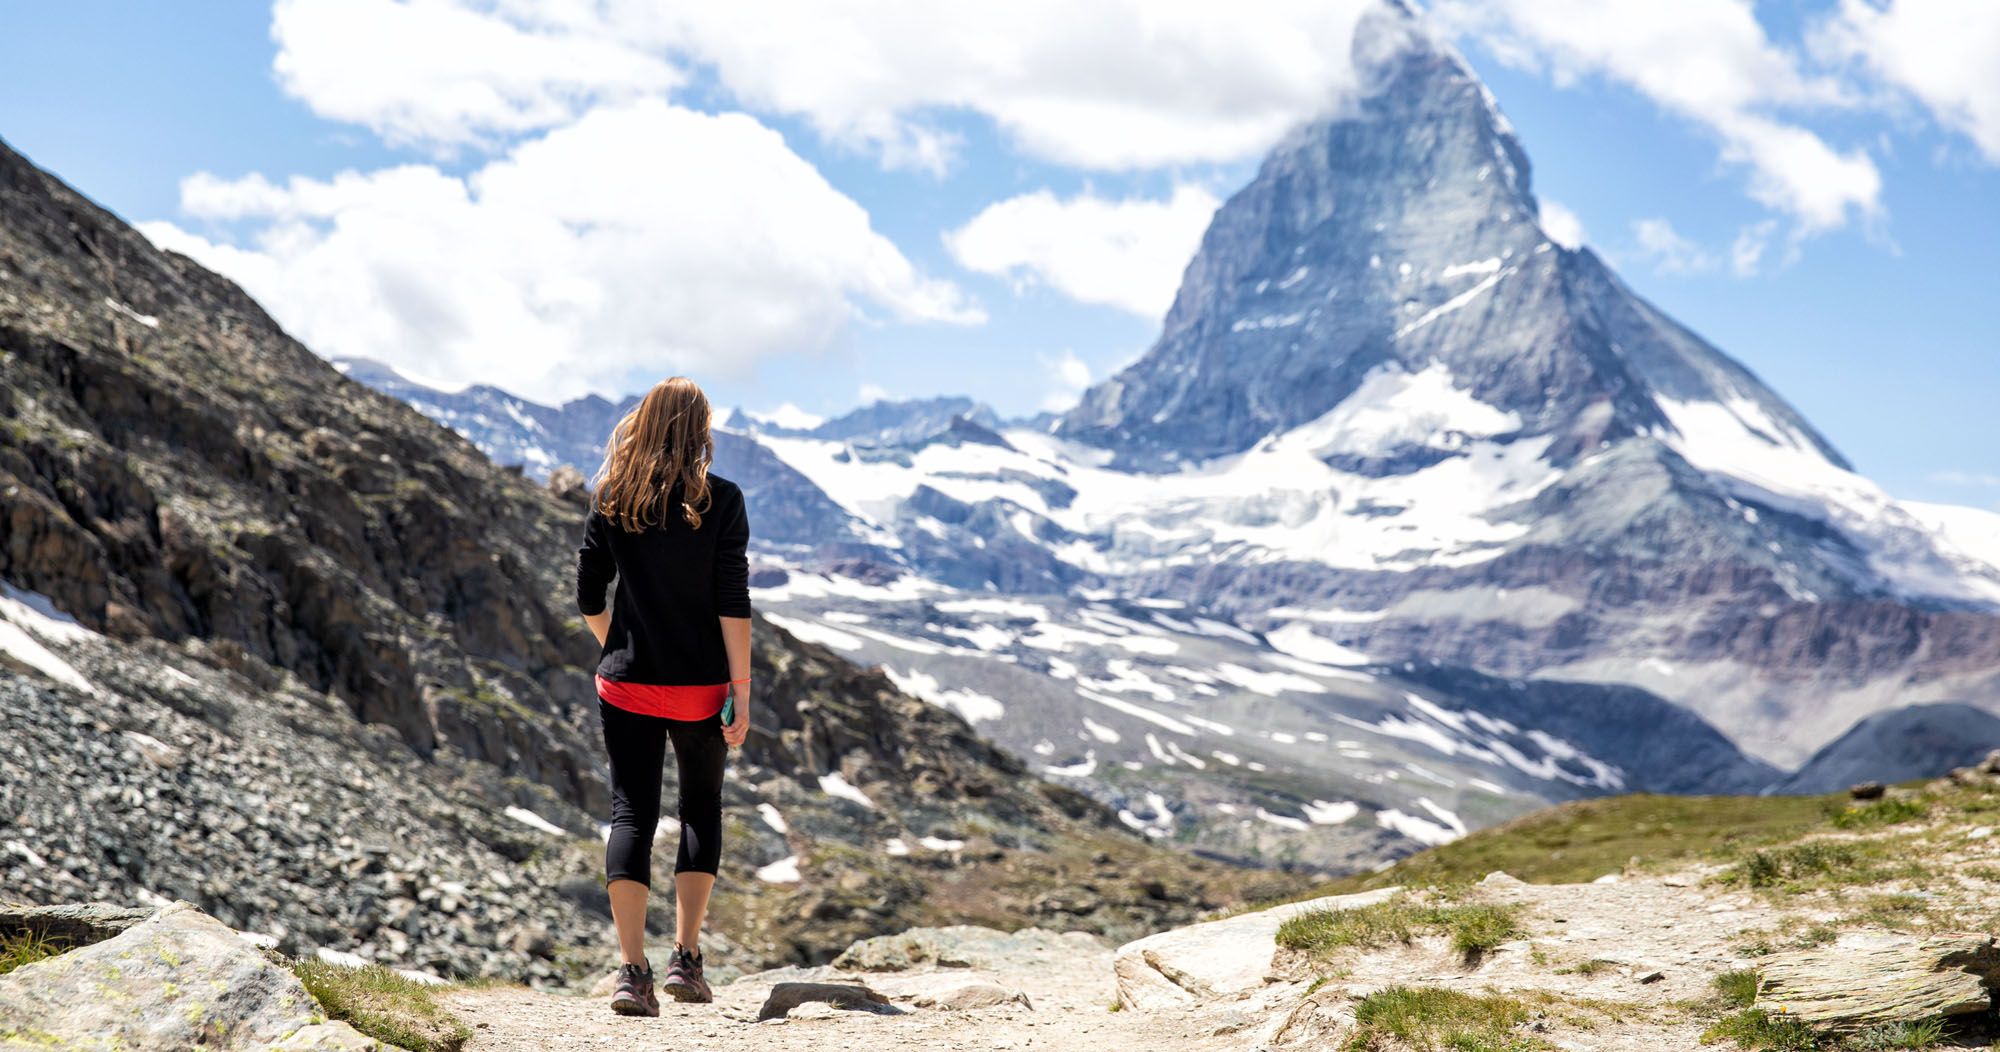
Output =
[{"x1": 1296, "y1": 794, "x2": 1846, "y2": 898}]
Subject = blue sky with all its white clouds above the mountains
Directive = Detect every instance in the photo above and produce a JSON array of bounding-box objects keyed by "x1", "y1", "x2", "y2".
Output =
[{"x1": 0, "y1": 0, "x2": 2000, "y2": 506}]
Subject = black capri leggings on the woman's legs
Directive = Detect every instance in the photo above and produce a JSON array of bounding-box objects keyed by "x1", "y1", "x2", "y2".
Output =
[{"x1": 598, "y1": 698, "x2": 730, "y2": 886}]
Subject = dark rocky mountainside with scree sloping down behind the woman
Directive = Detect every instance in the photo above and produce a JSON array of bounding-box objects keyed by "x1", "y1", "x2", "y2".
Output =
[{"x1": 0, "y1": 136, "x2": 1286, "y2": 982}]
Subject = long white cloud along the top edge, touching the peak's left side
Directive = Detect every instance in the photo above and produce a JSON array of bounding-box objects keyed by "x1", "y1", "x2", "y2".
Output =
[{"x1": 272, "y1": 0, "x2": 1382, "y2": 172}]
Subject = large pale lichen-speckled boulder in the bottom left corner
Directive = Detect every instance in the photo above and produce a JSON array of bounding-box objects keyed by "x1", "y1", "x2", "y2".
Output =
[{"x1": 0, "y1": 902, "x2": 380, "y2": 1052}]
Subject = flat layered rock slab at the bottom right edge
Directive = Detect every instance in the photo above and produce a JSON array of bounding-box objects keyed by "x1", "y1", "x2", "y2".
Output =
[{"x1": 1756, "y1": 934, "x2": 2000, "y2": 1030}]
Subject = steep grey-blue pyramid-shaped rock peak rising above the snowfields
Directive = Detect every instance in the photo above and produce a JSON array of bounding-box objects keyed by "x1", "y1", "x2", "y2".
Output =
[{"x1": 1058, "y1": 10, "x2": 1842, "y2": 482}]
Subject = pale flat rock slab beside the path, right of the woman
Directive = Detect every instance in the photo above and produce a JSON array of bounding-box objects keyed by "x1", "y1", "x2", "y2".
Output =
[{"x1": 1112, "y1": 888, "x2": 1398, "y2": 1010}]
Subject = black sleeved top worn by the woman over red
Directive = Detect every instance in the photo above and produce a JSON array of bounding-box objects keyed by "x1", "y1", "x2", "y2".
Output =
[{"x1": 576, "y1": 474, "x2": 750, "y2": 686}]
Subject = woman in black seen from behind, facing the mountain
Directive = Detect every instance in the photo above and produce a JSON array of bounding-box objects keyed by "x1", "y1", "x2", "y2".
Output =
[{"x1": 576, "y1": 376, "x2": 750, "y2": 1016}]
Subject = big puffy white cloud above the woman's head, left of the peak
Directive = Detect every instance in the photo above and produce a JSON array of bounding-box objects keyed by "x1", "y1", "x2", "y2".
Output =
[{"x1": 142, "y1": 100, "x2": 984, "y2": 400}]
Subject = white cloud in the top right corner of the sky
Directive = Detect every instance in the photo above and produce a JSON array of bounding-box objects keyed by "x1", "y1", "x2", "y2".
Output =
[{"x1": 1814, "y1": 0, "x2": 2000, "y2": 164}]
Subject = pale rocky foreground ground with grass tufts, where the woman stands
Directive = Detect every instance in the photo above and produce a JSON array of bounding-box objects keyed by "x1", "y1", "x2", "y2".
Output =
[{"x1": 15, "y1": 754, "x2": 2000, "y2": 1052}]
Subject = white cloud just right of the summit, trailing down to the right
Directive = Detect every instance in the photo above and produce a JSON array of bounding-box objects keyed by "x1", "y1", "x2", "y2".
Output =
[{"x1": 1432, "y1": 0, "x2": 1882, "y2": 234}]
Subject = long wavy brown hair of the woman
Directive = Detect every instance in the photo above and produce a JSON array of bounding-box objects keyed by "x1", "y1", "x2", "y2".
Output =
[{"x1": 592, "y1": 376, "x2": 716, "y2": 534}]
